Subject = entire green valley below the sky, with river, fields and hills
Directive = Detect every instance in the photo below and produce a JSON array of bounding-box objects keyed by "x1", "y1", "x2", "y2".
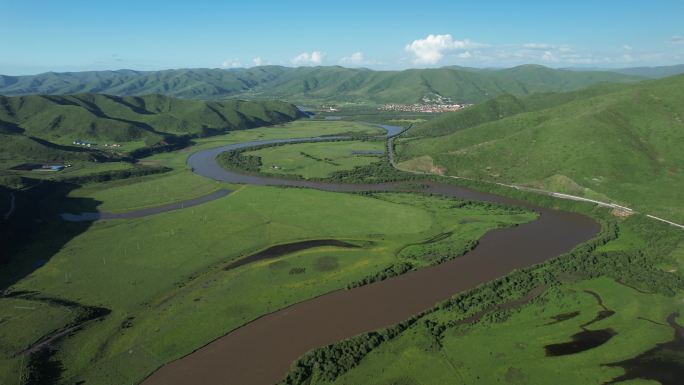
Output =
[{"x1": 0, "y1": 56, "x2": 684, "y2": 385}]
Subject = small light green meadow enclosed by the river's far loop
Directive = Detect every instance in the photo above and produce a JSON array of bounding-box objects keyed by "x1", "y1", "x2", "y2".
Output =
[{"x1": 244, "y1": 140, "x2": 385, "y2": 179}]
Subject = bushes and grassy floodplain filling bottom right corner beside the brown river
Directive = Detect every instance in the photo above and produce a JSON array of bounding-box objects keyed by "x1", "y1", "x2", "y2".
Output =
[{"x1": 283, "y1": 200, "x2": 684, "y2": 384}]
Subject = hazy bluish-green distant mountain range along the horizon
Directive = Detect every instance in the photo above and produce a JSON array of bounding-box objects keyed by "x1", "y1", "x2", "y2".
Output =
[{"x1": 0, "y1": 65, "x2": 644, "y2": 103}]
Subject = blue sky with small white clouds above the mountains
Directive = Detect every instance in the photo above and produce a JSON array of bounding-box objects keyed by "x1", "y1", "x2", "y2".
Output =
[{"x1": 0, "y1": 0, "x2": 684, "y2": 75}]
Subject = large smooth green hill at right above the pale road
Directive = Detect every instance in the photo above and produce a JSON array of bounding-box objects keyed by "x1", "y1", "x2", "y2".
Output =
[{"x1": 398, "y1": 75, "x2": 684, "y2": 221}]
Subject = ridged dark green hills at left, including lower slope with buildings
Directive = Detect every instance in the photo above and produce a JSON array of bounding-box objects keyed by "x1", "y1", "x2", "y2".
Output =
[{"x1": 0, "y1": 94, "x2": 303, "y2": 166}]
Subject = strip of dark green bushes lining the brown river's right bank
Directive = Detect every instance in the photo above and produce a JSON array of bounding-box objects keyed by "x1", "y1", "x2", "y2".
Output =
[{"x1": 281, "y1": 210, "x2": 684, "y2": 385}]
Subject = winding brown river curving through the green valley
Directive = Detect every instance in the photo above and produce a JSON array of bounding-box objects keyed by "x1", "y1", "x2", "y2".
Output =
[{"x1": 143, "y1": 125, "x2": 599, "y2": 385}]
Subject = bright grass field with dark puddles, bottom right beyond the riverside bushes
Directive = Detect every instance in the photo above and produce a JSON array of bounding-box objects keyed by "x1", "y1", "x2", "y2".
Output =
[{"x1": 322, "y1": 278, "x2": 684, "y2": 385}]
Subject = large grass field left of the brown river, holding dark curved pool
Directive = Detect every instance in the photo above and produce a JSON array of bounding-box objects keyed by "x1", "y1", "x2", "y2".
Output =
[{"x1": 0, "y1": 180, "x2": 533, "y2": 384}]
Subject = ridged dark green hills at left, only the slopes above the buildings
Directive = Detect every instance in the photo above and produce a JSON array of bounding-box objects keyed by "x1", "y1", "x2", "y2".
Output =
[{"x1": 0, "y1": 94, "x2": 302, "y2": 144}]
